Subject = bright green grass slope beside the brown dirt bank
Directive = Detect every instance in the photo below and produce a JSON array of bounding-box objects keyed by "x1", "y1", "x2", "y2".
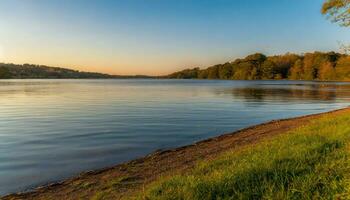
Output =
[{"x1": 137, "y1": 115, "x2": 350, "y2": 200}]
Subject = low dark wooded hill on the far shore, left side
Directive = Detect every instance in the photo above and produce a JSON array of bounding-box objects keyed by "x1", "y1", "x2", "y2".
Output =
[{"x1": 0, "y1": 63, "x2": 149, "y2": 79}]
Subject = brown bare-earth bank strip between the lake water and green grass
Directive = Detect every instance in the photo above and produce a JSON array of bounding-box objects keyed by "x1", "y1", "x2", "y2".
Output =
[{"x1": 1, "y1": 107, "x2": 350, "y2": 200}]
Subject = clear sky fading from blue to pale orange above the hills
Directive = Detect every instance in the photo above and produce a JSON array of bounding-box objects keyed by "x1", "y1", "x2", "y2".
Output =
[{"x1": 0, "y1": 0, "x2": 350, "y2": 75}]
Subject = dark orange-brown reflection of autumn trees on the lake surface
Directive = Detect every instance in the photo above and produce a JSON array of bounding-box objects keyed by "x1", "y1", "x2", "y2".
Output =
[{"x1": 226, "y1": 84, "x2": 350, "y2": 103}]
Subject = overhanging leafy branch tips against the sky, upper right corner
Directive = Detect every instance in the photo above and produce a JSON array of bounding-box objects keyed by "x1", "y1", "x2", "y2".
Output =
[{"x1": 321, "y1": 0, "x2": 350, "y2": 26}]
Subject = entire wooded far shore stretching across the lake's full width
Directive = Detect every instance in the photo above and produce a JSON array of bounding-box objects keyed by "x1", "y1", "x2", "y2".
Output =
[{"x1": 0, "y1": 51, "x2": 350, "y2": 81}]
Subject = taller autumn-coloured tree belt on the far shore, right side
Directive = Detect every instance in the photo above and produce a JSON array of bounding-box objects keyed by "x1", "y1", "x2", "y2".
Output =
[{"x1": 164, "y1": 52, "x2": 350, "y2": 81}]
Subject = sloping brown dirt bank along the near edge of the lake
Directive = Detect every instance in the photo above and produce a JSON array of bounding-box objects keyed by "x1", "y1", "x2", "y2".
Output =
[{"x1": 2, "y1": 108, "x2": 350, "y2": 199}]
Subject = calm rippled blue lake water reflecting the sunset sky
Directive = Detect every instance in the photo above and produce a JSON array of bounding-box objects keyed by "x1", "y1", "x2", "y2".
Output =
[{"x1": 0, "y1": 80, "x2": 350, "y2": 195}]
